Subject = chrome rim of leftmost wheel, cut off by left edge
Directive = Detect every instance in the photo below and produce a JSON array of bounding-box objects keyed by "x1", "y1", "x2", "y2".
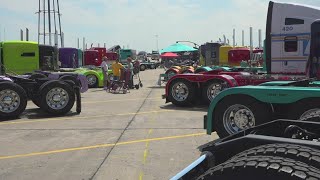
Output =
[{"x1": 0, "y1": 89, "x2": 20, "y2": 113}]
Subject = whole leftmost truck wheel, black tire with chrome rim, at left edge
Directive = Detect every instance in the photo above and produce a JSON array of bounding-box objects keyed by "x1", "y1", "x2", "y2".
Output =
[{"x1": 0, "y1": 82, "x2": 27, "y2": 118}]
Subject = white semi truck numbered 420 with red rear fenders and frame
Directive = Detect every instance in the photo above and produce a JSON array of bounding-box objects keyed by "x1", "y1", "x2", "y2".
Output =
[{"x1": 163, "y1": 1, "x2": 320, "y2": 106}]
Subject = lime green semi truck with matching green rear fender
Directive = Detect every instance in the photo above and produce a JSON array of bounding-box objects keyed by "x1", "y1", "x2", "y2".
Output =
[{"x1": 0, "y1": 41, "x2": 112, "y2": 89}]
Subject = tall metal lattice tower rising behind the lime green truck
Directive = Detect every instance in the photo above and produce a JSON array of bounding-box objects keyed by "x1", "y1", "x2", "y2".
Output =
[{"x1": 36, "y1": 0, "x2": 64, "y2": 47}]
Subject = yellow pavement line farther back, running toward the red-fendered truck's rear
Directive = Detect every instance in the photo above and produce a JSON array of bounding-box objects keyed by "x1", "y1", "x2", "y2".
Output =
[{"x1": 0, "y1": 110, "x2": 174, "y2": 126}]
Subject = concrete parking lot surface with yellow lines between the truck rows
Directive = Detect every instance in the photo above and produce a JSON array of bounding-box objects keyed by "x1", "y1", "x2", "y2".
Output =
[{"x1": 0, "y1": 69, "x2": 217, "y2": 180}]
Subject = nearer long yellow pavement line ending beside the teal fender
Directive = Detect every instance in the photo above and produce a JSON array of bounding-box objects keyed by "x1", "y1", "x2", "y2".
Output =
[{"x1": 0, "y1": 133, "x2": 206, "y2": 160}]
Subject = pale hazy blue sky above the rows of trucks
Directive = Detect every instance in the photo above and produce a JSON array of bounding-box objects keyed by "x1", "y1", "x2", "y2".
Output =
[{"x1": 0, "y1": 0, "x2": 320, "y2": 52}]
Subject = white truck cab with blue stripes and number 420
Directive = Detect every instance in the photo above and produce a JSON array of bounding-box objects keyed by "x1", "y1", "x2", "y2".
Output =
[{"x1": 265, "y1": 1, "x2": 320, "y2": 76}]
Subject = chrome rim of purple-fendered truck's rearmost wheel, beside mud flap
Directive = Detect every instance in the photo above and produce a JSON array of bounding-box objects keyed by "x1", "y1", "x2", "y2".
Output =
[{"x1": 46, "y1": 87, "x2": 69, "y2": 110}]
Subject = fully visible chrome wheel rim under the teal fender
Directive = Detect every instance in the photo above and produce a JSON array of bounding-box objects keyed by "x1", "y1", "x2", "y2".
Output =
[{"x1": 223, "y1": 104, "x2": 255, "y2": 134}]
